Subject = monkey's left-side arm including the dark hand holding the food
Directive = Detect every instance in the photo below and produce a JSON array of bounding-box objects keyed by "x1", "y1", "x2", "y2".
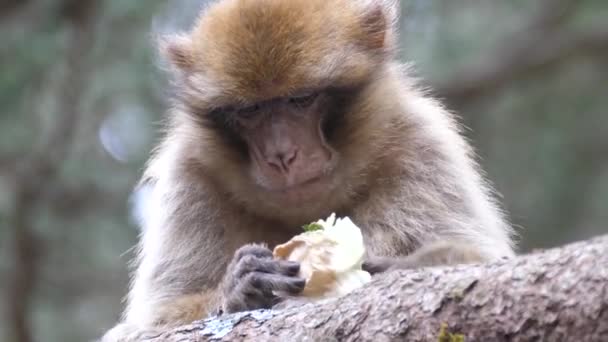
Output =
[{"x1": 104, "y1": 176, "x2": 304, "y2": 341}]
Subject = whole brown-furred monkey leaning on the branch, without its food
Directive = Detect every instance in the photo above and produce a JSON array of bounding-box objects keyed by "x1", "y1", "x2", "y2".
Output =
[{"x1": 105, "y1": 0, "x2": 515, "y2": 341}]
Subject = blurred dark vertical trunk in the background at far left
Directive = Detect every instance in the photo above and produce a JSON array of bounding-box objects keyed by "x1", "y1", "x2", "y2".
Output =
[{"x1": 6, "y1": 0, "x2": 98, "y2": 342}]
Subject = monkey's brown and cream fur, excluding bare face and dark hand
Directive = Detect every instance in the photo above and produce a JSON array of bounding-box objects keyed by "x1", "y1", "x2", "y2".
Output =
[{"x1": 106, "y1": 0, "x2": 513, "y2": 340}]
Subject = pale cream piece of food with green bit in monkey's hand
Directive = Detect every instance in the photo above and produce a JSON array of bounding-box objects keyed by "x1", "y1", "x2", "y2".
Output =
[{"x1": 273, "y1": 214, "x2": 371, "y2": 299}]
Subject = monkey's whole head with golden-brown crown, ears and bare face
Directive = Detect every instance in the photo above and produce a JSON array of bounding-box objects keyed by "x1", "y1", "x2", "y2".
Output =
[{"x1": 163, "y1": 0, "x2": 404, "y2": 222}]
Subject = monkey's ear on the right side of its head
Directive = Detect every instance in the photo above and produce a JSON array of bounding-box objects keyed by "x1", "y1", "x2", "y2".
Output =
[{"x1": 362, "y1": 0, "x2": 400, "y2": 51}]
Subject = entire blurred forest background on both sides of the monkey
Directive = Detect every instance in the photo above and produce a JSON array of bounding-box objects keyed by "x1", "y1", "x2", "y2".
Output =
[{"x1": 0, "y1": 0, "x2": 608, "y2": 342}]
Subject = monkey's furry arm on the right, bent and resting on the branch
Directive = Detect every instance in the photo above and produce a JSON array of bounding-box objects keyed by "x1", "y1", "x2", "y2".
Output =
[{"x1": 354, "y1": 133, "x2": 514, "y2": 273}]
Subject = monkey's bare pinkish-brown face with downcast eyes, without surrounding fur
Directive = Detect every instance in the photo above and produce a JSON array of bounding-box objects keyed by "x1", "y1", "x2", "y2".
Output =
[{"x1": 211, "y1": 91, "x2": 350, "y2": 204}]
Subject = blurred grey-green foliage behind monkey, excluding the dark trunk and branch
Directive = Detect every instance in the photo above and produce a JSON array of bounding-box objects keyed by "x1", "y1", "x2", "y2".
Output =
[{"x1": 0, "y1": 0, "x2": 608, "y2": 342}]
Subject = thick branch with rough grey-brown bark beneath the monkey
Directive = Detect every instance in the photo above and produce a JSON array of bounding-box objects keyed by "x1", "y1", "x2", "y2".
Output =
[{"x1": 150, "y1": 236, "x2": 608, "y2": 341}]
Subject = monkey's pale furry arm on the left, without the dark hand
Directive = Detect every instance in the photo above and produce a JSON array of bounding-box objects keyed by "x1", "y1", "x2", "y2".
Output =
[{"x1": 116, "y1": 177, "x2": 233, "y2": 329}]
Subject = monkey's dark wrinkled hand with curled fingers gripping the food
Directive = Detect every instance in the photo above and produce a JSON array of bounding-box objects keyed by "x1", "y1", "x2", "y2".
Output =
[{"x1": 222, "y1": 244, "x2": 306, "y2": 312}]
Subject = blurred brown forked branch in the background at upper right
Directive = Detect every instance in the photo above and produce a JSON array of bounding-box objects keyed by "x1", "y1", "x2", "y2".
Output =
[{"x1": 434, "y1": 0, "x2": 608, "y2": 109}]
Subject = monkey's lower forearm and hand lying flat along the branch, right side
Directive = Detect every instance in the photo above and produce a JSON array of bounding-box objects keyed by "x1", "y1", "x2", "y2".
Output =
[{"x1": 362, "y1": 242, "x2": 489, "y2": 274}]
